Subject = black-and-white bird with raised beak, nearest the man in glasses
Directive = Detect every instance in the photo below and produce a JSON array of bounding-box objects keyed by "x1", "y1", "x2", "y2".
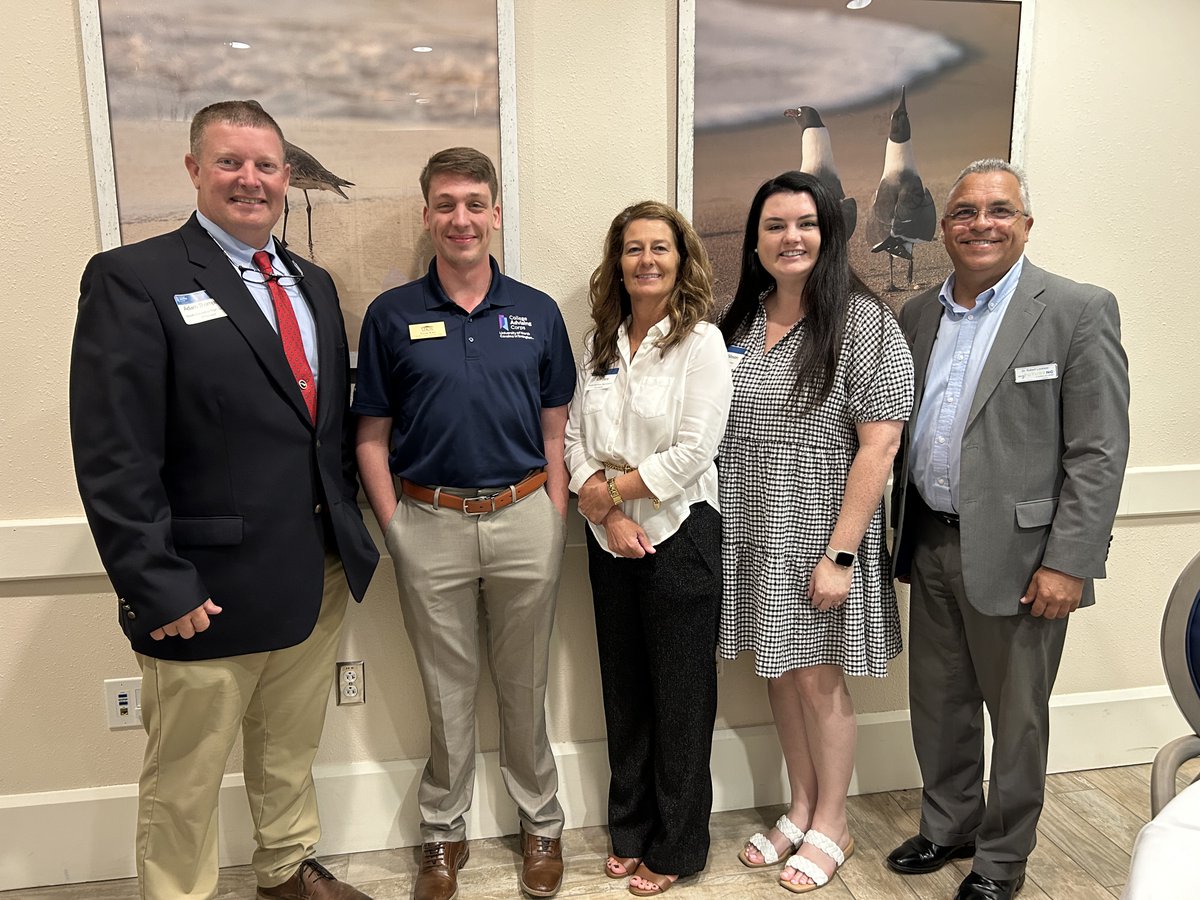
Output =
[{"x1": 866, "y1": 88, "x2": 937, "y2": 290}]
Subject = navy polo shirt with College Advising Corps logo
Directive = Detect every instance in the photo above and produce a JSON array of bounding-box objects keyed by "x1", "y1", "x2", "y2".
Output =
[{"x1": 352, "y1": 259, "x2": 575, "y2": 487}]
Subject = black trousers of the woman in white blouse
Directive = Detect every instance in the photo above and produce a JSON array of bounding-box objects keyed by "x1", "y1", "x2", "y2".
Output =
[{"x1": 588, "y1": 503, "x2": 721, "y2": 875}]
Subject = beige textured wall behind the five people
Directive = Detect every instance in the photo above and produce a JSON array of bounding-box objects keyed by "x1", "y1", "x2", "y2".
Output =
[{"x1": 0, "y1": 0, "x2": 1200, "y2": 794}]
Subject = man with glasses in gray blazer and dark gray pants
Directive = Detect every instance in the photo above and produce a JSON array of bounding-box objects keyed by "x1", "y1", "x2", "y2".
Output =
[{"x1": 887, "y1": 160, "x2": 1129, "y2": 900}]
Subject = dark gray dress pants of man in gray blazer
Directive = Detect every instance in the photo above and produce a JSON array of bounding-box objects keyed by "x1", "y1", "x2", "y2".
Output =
[{"x1": 908, "y1": 514, "x2": 1067, "y2": 880}]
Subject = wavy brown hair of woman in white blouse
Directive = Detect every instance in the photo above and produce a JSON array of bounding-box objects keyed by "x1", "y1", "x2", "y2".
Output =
[{"x1": 587, "y1": 200, "x2": 713, "y2": 376}]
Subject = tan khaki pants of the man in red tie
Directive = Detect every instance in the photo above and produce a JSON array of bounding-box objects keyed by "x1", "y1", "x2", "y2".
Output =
[{"x1": 136, "y1": 556, "x2": 349, "y2": 900}]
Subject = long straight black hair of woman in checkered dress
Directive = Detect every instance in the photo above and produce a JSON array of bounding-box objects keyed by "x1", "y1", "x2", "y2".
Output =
[{"x1": 720, "y1": 172, "x2": 878, "y2": 410}]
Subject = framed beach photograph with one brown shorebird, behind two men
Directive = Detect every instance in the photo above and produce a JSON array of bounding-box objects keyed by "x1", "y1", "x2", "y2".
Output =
[{"x1": 79, "y1": 0, "x2": 520, "y2": 359}]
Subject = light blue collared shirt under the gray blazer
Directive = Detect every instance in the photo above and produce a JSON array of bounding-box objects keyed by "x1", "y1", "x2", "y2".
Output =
[{"x1": 908, "y1": 256, "x2": 1025, "y2": 512}]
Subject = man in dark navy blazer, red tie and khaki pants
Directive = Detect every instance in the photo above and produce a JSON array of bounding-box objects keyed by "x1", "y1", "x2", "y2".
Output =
[{"x1": 71, "y1": 101, "x2": 378, "y2": 900}]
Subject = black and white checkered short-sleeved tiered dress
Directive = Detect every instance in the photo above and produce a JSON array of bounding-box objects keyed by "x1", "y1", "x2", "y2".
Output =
[{"x1": 718, "y1": 294, "x2": 913, "y2": 678}]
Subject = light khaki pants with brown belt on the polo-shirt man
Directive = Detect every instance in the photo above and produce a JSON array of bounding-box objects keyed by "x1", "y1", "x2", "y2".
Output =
[{"x1": 386, "y1": 491, "x2": 566, "y2": 841}]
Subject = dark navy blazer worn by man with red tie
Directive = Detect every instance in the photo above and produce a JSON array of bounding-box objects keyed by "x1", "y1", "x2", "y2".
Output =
[{"x1": 71, "y1": 216, "x2": 379, "y2": 660}]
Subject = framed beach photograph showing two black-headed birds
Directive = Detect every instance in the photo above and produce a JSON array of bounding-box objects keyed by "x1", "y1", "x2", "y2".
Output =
[{"x1": 677, "y1": 0, "x2": 1033, "y2": 308}]
